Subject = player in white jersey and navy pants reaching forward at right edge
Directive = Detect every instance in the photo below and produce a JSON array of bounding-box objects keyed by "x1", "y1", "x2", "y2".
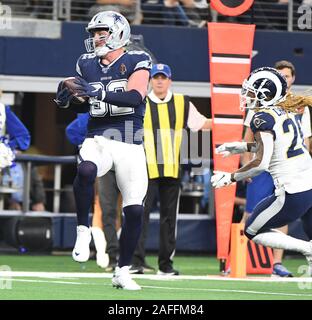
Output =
[{"x1": 211, "y1": 67, "x2": 312, "y2": 275}]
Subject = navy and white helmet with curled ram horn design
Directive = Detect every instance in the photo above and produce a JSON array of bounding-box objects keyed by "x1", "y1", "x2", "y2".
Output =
[{"x1": 240, "y1": 67, "x2": 287, "y2": 110}]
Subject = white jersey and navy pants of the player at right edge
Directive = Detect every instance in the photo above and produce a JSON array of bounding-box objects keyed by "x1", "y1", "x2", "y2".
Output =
[{"x1": 246, "y1": 108, "x2": 312, "y2": 239}]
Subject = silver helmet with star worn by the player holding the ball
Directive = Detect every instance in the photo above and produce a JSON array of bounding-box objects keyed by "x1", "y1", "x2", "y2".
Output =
[{"x1": 85, "y1": 11, "x2": 130, "y2": 57}]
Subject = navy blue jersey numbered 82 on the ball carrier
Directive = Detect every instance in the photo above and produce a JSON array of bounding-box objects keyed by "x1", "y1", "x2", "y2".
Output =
[{"x1": 76, "y1": 51, "x2": 152, "y2": 144}]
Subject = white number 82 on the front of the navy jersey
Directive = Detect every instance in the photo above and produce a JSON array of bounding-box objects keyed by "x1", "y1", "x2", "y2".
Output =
[{"x1": 90, "y1": 80, "x2": 134, "y2": 117}]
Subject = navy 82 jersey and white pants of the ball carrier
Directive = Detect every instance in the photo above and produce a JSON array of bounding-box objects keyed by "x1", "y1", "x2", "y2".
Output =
[{"x1": 76, "y1": 51, "x2": 151, "y2": 207}]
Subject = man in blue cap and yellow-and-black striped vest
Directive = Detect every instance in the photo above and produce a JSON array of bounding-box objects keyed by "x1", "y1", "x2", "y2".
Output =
[{"x1": 130, "y1": 64, "x2": 211, "y2": 275}]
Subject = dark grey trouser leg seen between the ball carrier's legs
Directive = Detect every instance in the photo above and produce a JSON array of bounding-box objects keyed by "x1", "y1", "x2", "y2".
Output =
[{"x1": 98, "y1": 170, "x2": 119, "y2": 263}]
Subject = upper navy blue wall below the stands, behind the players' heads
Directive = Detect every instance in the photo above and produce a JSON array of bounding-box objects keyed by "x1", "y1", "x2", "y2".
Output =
[{"x1": 0, "y1": 22, "x2": 312, "y2": 84}]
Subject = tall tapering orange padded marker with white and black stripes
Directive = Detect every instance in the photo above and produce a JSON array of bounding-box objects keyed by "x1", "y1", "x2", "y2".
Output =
[{"x1": 208, "y1": 22, "x2": 255, "y2": 262}]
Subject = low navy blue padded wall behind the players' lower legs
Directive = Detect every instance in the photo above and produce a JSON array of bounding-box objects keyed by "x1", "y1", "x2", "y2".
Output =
[{"x1": 0, "y1": 211, "x2": 308, "y2": 254}]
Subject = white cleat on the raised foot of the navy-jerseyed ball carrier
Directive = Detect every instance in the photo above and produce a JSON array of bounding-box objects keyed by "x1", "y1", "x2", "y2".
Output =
[{"x1": 72, "y1": 225, "x2": 91, "y2": 262}]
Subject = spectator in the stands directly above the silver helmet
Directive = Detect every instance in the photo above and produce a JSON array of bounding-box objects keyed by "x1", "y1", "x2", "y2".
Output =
[{"x1": 88, "y1": 0, "x2": 141, "y2": 24}]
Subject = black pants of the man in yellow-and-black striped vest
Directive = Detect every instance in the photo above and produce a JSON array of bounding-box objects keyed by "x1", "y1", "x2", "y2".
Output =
[{"x1": 133, "y1": 178, "x2": 180, "y2": 271}]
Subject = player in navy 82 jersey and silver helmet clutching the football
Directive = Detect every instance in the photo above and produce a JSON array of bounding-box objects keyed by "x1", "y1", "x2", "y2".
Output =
[{"x1": 55, "y1": 11, "x2": 151, "y2": 290}]
